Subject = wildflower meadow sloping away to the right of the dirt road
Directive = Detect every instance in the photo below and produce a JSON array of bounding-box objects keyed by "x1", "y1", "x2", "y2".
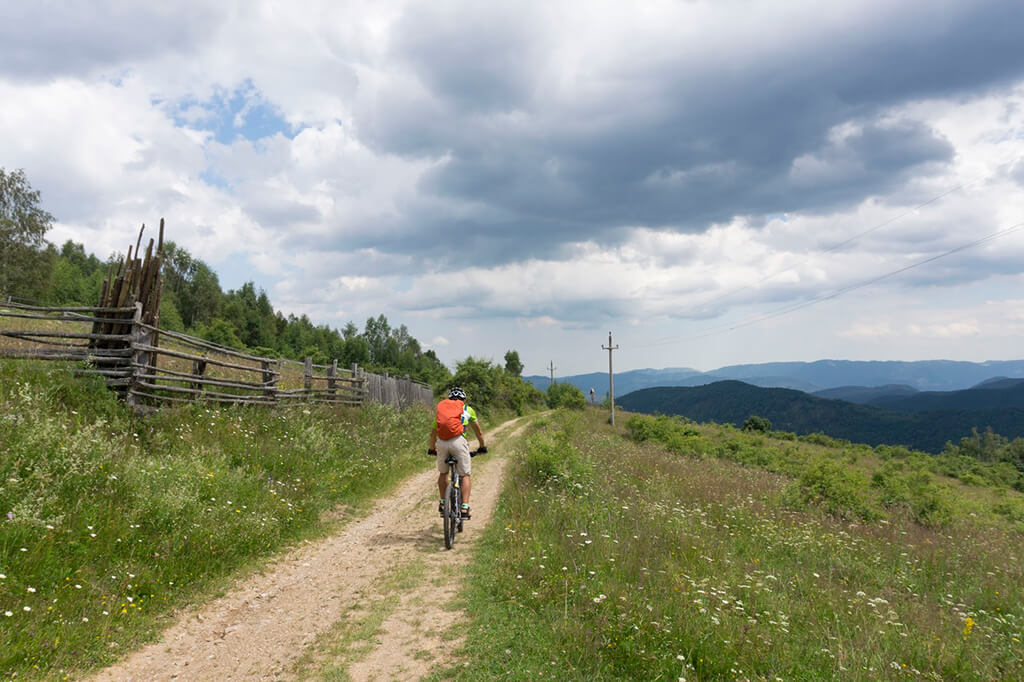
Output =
[{"x1": 437, "y1": 413, "x2": 1024, "y2": 680}]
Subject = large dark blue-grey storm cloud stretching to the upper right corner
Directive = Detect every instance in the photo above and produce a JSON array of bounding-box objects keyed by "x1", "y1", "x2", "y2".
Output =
[{"x1": 354, "y1": 1, "x2": 1024, "y2": 262}]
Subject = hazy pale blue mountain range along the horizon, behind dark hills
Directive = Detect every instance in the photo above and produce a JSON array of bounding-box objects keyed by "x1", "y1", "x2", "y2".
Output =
[{"x1": 525, "y1": 359, "x2": 1024, "y2": 393}]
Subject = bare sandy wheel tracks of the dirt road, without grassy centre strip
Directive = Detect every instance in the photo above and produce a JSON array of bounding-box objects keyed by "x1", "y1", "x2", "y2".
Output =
[{"x1": 92, "y1": 411, "x2": 521, "y2": 682}]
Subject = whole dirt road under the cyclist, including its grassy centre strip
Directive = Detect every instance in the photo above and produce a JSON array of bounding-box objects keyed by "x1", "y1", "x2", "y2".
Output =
[{"x1": 92, "y1": 413, "x2": 532, "y2": 682}]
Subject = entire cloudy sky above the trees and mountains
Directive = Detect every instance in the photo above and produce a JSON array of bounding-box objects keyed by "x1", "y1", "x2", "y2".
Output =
[{"x1": 0, "y1": 0, "x2": 1024, "y2": 375}]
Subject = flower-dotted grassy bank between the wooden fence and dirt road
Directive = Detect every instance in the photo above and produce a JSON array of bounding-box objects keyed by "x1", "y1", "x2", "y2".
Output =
[{"x1": 0, "y1": 361, "x2": 431, "y2": 679}]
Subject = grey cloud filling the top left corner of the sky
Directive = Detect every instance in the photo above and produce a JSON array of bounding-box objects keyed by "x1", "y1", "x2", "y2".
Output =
[{"x1": 0, "y1": 0, "x2": 221, "y2": 80}]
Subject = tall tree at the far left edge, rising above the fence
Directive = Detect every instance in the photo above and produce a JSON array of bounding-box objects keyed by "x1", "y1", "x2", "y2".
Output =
[{"x1": 0, "y1": 168, "x2": 54, "y2": 297}]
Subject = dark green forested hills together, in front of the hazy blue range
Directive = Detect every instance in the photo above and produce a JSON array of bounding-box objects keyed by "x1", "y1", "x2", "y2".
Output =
[{"x1": 616, "y1": 380, "x2": 1024, "y2": 453}]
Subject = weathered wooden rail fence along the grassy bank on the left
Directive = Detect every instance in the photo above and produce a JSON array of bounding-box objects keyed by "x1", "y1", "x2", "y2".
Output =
[{"x1": 0, "y1": 300, "x2": 433, "y2": 412}]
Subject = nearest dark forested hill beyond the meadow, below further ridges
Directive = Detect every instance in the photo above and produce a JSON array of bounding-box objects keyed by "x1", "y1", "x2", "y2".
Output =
[{"x1": 616, "y1": 381, "x2": 1024, "y2": 453}]
